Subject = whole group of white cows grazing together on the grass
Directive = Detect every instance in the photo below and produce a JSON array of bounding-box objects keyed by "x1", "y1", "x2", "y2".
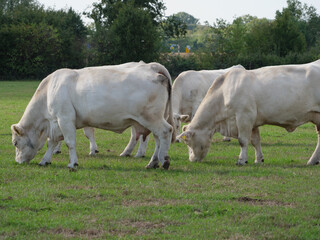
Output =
[{"x1": 11, "y1": 60, "x2": 320, "y2": 169}]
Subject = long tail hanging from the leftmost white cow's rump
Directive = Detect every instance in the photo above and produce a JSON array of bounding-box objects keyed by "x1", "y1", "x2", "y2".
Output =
[{"x1": 151, "y1": 64, "x2": 176, "y2": 143}]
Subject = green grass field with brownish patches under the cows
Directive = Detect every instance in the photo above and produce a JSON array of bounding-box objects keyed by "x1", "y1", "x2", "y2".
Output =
[{"x1": 0, "y1": 82, "x2": 320, "y2": 239}]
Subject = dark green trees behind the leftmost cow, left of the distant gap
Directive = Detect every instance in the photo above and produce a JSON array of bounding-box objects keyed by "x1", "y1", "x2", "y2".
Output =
[{"x1": 0, "y1": 0, "x2": 186, "y2": 79}]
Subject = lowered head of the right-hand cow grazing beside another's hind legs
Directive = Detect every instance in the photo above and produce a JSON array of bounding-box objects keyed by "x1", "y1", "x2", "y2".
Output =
[{"x1": 177, "y1": 125, "x2": 213, "y2": 162}]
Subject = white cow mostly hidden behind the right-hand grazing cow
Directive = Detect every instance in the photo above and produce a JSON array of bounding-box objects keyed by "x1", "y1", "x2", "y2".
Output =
[{"x1": 172, "y1": 65, "x2": 244, "y2": 140}]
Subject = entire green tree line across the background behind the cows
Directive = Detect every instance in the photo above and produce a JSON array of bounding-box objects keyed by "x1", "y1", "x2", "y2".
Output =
[{"x1": 0, "y1": 0, "x2": 320, "y2": 79}]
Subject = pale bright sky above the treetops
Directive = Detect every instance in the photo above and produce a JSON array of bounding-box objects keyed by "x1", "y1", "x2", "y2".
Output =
[{"x1": 38, "y1": 0, "x2": 320, "y2": 25}]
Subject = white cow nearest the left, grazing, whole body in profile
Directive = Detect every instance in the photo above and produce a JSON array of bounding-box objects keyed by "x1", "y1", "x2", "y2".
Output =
[{"x1": 11, "y1": 63, "x2": 175, "y2": 169}]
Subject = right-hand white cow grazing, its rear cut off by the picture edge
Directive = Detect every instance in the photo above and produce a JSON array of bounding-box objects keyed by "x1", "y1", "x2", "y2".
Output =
[{"x1": 178, "y1": 60, "x2": 320, "y2": 165}]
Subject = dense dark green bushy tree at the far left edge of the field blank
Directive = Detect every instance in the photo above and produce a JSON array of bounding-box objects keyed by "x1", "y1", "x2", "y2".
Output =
[{"x1": 0, "y1": 0, "x2": 86, "y2": 78}]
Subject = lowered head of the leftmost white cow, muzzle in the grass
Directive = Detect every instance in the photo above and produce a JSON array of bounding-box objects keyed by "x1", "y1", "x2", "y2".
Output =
[{"x1": 11, "y1": 124, "x2": 46, "y2": 163}]
